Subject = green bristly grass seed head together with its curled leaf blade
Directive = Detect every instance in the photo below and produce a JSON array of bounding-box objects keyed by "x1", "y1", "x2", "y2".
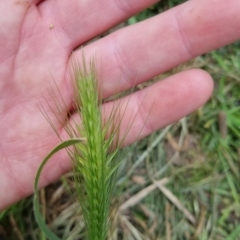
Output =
[{"x1": 34, "y1": 58, "x2": 127, "y2": 240}]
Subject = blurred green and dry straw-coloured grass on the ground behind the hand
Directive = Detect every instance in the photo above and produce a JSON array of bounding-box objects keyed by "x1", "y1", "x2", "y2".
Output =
[{"x1": 0, "y1": 0, "x2": 240, "y2": 240}]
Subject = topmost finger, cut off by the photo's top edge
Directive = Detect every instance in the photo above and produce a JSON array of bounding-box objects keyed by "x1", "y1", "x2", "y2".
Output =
[{"x1": 37, "y1": 0, "x2": 158, "y2": 48}]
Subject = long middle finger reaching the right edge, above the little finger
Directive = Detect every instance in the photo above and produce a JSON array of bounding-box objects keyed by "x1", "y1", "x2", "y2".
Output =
[{"x1": 69, "y1": 0, "x2": 240, "y2": 97}]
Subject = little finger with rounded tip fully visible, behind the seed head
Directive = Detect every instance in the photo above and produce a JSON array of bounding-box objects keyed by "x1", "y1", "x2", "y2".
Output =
[{"x1": 62, "y1": 69, "x2": 213, "y2": 145}]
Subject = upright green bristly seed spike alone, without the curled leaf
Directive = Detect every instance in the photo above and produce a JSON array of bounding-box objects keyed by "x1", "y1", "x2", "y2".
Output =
[{"x1": 72, "y1": 58, "x2": 123, "y2": 240}]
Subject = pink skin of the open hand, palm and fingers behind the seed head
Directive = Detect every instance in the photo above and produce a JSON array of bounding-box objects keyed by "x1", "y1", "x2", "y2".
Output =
[{"x1": 0, "y1": 0, "x2": 240, "y2": 210}]
